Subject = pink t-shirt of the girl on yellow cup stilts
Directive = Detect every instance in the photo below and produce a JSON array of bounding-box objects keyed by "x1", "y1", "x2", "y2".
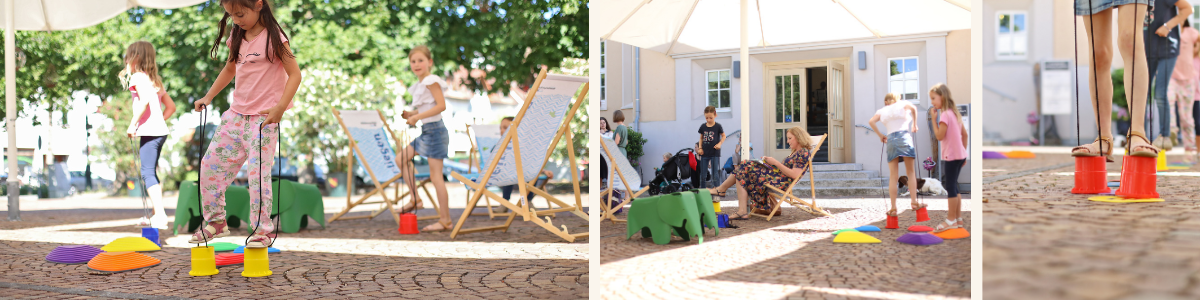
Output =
[{"x1": 226, "y1": 30, "x2": 295, "y2": 115}]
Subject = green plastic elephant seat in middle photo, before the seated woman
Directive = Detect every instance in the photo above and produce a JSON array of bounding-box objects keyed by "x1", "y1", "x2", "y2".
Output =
[{"x1": 625, "y1": 193, "x2": 700, "y2": 245}]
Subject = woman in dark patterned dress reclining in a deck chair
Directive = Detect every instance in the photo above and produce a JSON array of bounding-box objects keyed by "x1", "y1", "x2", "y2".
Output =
[{"x1": 708, "y1": 127, "x2": 812, "y2": 220}]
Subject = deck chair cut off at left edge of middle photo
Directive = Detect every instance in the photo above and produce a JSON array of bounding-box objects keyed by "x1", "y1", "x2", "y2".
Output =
[{"x1": 600, "y1": 138, "x2": 650, "y2": 223}]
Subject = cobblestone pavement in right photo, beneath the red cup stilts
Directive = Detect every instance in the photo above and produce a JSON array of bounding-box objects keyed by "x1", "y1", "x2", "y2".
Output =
[{"x1": 982, "y1": 149, "x2": 1200, "y2": 299}]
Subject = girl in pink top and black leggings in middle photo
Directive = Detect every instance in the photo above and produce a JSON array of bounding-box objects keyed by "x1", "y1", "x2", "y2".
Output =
[{"x1": 929, "y1": 83, "x2": 967, "y2": 233}]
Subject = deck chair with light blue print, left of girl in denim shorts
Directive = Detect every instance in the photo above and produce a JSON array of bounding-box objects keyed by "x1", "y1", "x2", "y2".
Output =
[{"x1": 329, "y1": 110, "x2": 440, "y2": 226}]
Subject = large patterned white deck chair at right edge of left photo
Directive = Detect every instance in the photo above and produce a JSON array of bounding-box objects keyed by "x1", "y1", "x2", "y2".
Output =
[{"x1": 450, "y1": 67, "x2": 588, "y2": 241}]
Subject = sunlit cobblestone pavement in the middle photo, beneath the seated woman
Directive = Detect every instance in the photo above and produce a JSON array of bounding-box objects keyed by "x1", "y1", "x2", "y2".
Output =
[{"x1": 596, "y1": 196, "x2": 971, "y2": 299}]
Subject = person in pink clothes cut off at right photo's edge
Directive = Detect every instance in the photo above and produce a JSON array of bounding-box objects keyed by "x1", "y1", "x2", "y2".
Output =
[{"x1": 1166, "y1": 20, "x2": 1200, "y2": 162}]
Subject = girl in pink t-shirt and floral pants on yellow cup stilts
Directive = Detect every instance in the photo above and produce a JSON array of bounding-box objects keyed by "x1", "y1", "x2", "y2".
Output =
[{"x1": 190, "y1": 0, "x2": 300, "y2": 248}]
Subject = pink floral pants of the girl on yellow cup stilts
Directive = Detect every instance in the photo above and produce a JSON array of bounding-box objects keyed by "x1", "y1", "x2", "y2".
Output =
[{"x1": 200, "y1": 110, "x2": 280, "y2": 235}]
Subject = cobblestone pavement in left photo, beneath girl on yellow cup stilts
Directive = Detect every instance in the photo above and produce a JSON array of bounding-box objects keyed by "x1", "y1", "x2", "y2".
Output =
[{"x1": 0, "y1": 187, "x2": 589, "y2": 299}]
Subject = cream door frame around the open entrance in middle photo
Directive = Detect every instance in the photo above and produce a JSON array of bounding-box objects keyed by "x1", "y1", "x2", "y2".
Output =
[{"x1": 762, "y1": 58, "x2": 856, "y2": 163}]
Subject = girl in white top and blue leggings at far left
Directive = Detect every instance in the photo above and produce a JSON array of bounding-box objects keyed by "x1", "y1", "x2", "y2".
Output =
[{"x1": 118, "y1": 41, "x2": 175, "y2": 229}]
